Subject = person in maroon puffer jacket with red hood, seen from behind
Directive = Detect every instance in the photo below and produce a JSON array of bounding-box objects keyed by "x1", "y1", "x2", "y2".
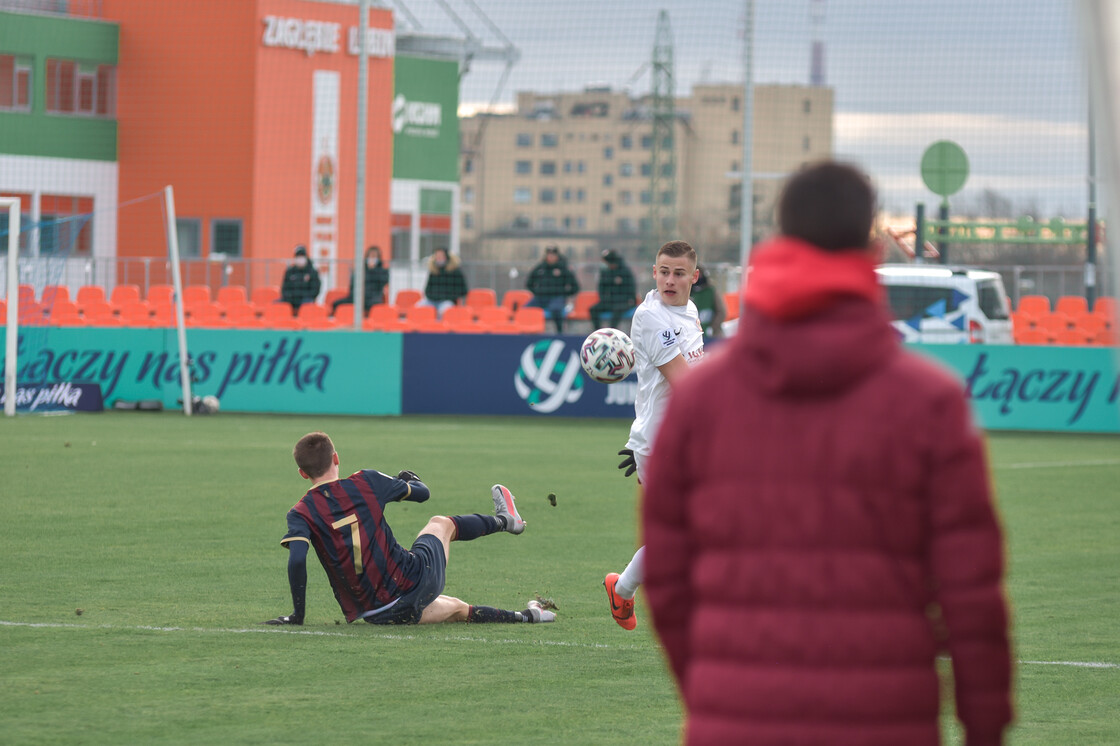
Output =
[{"x1": 643, "y1": 164, "x2": 1011, "y2": 746}]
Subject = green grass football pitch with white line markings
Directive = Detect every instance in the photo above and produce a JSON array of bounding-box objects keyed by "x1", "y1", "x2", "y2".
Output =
[{"x1": 0, "y1": 412, "x2": 1120, "y2": 745}]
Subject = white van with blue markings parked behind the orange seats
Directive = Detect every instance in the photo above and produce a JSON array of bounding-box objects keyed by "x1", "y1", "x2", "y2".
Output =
[{"x1": 876, "y1": 264, "x2": 1015, "y2": 345}]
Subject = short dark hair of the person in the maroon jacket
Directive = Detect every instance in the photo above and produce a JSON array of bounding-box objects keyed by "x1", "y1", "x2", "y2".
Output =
[{"x1": 777, "y1": 161, "x2": 876, "y2": 251}]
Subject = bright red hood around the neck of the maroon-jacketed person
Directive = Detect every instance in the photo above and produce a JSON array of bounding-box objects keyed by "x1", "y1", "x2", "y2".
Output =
[{"x1": 743, "y1": 236, "x2": 883, "y2": 320}]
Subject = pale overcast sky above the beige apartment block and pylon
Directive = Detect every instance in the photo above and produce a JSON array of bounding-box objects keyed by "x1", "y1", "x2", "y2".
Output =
[{"x1": 389, "y1": 0, "x2": 1088, "y2": 217}]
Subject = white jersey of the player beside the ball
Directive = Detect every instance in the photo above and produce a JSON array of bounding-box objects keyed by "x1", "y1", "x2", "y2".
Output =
[{"x1": 626, "y1": 289, "x2": 703, "y2": 465}]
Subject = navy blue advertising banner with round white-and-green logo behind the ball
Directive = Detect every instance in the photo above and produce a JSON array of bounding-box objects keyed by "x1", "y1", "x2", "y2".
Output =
[{"x1": 401, "y1": 334, "x2": 637, "y2": 418}]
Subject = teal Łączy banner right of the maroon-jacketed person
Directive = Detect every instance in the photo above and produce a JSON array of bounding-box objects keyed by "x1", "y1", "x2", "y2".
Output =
[{"x1": 911, "y1": 345, "x2": 1120, "y2": 432}]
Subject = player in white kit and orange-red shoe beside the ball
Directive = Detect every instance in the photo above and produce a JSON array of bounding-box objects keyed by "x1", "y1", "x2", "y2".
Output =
[{"x1": 603, "y1": 241, "x2": 703, "y2": 630}]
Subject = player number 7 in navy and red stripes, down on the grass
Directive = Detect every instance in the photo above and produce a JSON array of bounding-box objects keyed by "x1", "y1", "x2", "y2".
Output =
[{"x1": 264, "y1": 432, "x2": 556, "y2": 624}]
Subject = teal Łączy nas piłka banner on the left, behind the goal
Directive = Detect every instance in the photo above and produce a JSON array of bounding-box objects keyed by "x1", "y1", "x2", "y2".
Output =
[{"x1": 0, "y1": 327, "x2": 401, "y2": 414}]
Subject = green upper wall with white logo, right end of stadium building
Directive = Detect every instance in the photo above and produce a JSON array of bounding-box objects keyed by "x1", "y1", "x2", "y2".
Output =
[{"x1": 393, "y1": 56, "x2": 459, "y2": 183}]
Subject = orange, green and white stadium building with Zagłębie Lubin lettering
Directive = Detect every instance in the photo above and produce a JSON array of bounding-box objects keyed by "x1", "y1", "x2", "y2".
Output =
[{"x1": 0, "y1": 0, "x2": 459, "y2": 287}]
